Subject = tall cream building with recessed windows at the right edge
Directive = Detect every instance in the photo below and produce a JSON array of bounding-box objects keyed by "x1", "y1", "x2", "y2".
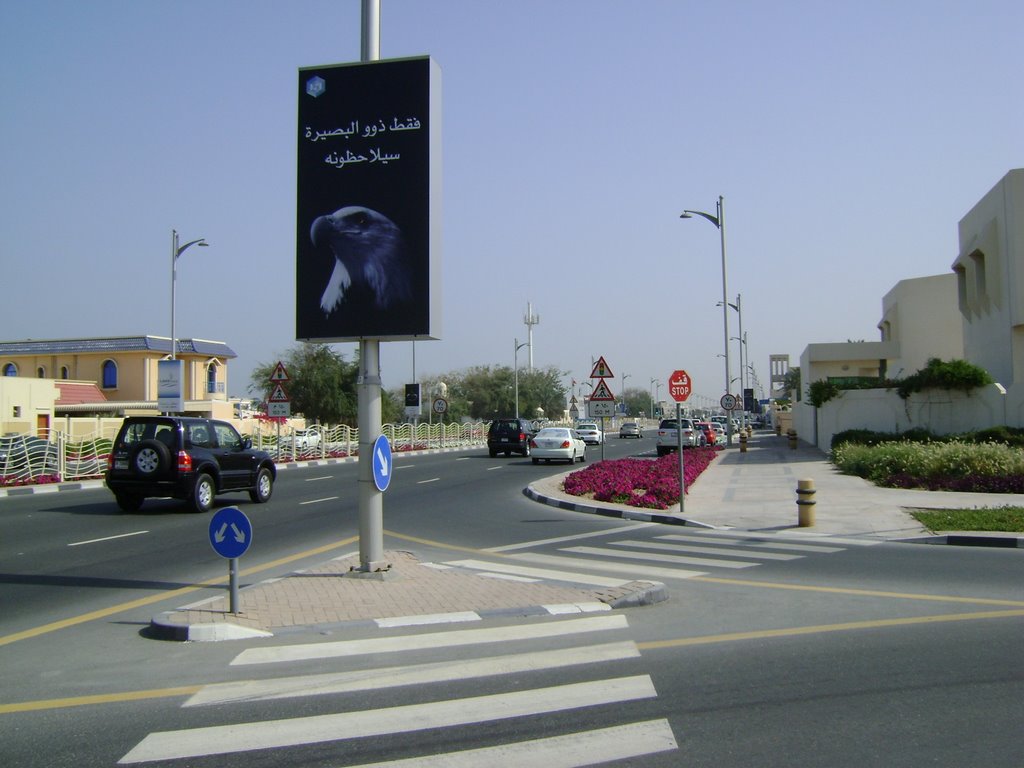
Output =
[{"x1": 952, "y1": 169, "x2": 1024, "y2": 387}]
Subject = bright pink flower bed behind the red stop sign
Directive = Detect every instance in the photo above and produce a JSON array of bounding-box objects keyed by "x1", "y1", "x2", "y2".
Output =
[{"x1": 563, "y1": 447, "x2": 720, "y2": 509}]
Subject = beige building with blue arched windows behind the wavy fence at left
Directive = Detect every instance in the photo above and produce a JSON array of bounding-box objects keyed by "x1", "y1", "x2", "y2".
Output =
[{"x1": 0, "y1": 336, "x2": 237, "y2": 432}]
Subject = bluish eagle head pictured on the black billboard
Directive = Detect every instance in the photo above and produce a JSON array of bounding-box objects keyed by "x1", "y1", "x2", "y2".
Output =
[{"x1": 309, "y1": 206, "x2": 412, "y2": 315}]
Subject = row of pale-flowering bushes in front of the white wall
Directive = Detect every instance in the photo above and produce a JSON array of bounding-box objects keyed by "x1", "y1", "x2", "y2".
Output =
[{"x1": 833, "y1": 440, "x2": 1024, "y2": 494}]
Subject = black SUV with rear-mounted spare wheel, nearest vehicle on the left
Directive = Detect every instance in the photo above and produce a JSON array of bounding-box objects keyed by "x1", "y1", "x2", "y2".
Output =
[{"x1": 106, "y1": 416, "x2": 278, "y2": 512}]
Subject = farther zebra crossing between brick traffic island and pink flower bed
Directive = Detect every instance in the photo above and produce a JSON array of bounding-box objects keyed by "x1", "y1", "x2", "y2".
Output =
[{"x1": 456, "y1": 526, "x2": 881, "y2": 587}]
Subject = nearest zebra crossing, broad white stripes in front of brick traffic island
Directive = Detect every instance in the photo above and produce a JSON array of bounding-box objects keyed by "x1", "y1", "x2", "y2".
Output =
[{"x1": 119, "y1": 613, "x2": 678, "y2": 768}]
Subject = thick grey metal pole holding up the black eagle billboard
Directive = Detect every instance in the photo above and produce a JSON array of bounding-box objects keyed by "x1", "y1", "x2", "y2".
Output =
[{"x1": 358, "y1": 0, "x2": 390, "y2": 573}]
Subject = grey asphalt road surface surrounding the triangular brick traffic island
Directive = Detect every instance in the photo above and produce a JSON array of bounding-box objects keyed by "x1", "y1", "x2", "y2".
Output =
[{"x1": 0, "y1": 438, "x2": 1024, "y2": 768}]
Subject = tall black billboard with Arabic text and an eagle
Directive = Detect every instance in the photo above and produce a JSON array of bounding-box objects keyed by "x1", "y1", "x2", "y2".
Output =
[{"x1": 295, "y1": 56, "x2": 441, "y2": 341}]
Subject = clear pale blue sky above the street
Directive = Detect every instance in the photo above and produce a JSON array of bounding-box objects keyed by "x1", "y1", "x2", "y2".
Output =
[{"x1": 0, "y1": 0, "x2": 1024, "y2": 415}]
